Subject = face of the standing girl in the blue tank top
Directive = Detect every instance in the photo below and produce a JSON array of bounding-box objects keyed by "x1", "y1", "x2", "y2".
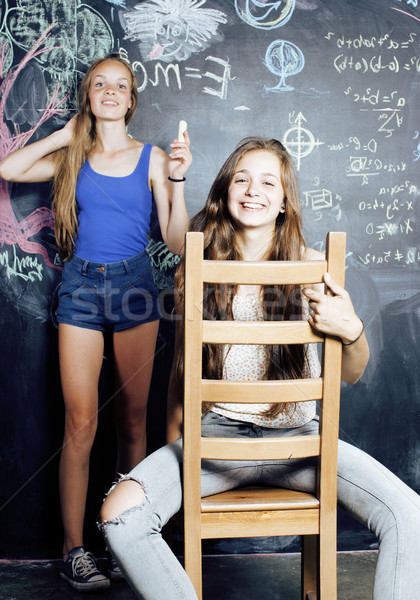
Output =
[{"x1": 89, "y1": 60, "x2": 133, "y2": 120}]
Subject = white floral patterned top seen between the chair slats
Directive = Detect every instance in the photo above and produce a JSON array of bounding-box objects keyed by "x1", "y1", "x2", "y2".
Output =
[{"x1": 211, "y1": 294, "x2": 321, "y2": 429}]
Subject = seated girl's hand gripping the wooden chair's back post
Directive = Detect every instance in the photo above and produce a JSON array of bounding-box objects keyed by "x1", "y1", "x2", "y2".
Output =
[{"x1": 303, "y1": 273, "x2": 363, "y2": 343}]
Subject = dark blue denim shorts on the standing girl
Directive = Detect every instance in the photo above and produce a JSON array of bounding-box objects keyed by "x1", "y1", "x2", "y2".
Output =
[{"x1": 57, "y1": 250, "x2": 161, "y2": 331}]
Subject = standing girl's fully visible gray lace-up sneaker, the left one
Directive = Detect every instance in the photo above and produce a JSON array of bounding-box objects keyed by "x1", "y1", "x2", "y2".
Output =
[{"x1": 59, "y1": 546, "x2": 110, "y2": 591}]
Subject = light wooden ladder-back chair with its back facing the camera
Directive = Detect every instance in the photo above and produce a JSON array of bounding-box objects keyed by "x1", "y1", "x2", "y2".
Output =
[{"x1": 183, "y1": 232, "x2": 346, "y2": 600}]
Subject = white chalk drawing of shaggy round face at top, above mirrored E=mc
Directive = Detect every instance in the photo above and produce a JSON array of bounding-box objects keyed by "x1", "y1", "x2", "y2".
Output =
[{"x1": 120, "y1": 0, "x2": 227, "y2": 62}]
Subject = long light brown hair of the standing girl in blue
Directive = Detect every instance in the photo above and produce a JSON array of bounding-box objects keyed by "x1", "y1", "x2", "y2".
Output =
[{"x1": 52, "y1": 54, "x2": 137, "y2": 261}]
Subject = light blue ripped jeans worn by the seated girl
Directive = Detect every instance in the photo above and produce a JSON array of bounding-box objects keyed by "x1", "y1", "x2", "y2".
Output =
[{"x1": 98, "y1": 413, "x2": 420, "y2": 600}]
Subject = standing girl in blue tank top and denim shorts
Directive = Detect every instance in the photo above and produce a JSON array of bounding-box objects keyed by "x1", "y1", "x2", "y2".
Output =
[{"x1": 0, "y1": 55, "x2": 192, "y2": 590}]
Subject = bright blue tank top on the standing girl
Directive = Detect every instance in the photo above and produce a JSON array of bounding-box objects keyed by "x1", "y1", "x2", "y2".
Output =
[{"x1": 75, "y1": 144, "x2": 152, "y2": 263}]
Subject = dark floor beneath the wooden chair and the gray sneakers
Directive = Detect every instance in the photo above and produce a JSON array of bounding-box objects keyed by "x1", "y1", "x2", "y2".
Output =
[{"x1": 0, "y1": 551, "x2": 377, "y2": 600}]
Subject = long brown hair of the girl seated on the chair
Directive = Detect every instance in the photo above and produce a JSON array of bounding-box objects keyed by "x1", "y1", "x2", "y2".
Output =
[{"x1": 175, "y1": 137, "x2": 305, "y2": 417}]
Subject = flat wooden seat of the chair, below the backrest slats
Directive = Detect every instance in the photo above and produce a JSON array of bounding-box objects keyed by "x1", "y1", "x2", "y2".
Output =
[{"x1": 201, "y1": 486, "x2": 319, "y2": 513}]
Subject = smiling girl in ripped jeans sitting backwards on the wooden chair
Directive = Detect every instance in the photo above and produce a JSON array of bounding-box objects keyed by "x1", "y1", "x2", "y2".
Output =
[{"x1": 99, "y1": 138, "x2": 420, "y2": 600}]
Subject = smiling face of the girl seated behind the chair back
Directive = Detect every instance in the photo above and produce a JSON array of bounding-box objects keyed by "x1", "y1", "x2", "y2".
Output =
[{"x1": 228, "y1": 150, "x2": 285, "y2": 234}]
